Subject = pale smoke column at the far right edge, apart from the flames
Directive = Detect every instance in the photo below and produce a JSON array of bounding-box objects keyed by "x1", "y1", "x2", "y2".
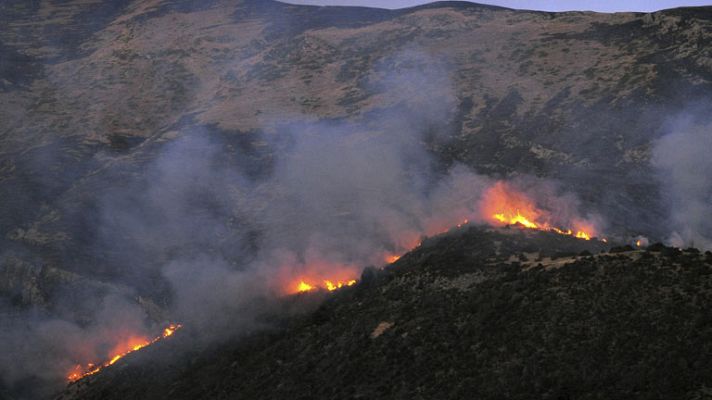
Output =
[{"x1": 652, "y1": 119, "x2": 712, "y2": 249}]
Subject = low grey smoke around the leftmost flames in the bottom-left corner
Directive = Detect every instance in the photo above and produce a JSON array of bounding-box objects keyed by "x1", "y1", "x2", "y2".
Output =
[{"x1": 0, "y1": 295, "x2": 146, "y2": 399}]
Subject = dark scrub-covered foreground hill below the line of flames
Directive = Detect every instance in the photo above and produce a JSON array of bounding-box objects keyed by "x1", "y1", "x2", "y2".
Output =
[{"x1": 59, "y1": 227, "x2": 712, "y2": 400}]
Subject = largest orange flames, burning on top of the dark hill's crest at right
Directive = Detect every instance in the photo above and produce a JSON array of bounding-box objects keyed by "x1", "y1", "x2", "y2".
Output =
[{"x1": 480, "y1": 182, "x2": 595, "y2": 240}]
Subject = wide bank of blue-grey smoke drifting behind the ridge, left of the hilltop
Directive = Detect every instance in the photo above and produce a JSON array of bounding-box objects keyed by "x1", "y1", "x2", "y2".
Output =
[{"x1": 0, "y1": 51, "x2": 600, "y2": 396}]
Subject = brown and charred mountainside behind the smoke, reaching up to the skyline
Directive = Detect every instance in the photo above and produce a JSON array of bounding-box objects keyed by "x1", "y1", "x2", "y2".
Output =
[{"x1": 0, "y1": 0, "x2": 712, "y2": 260}]
